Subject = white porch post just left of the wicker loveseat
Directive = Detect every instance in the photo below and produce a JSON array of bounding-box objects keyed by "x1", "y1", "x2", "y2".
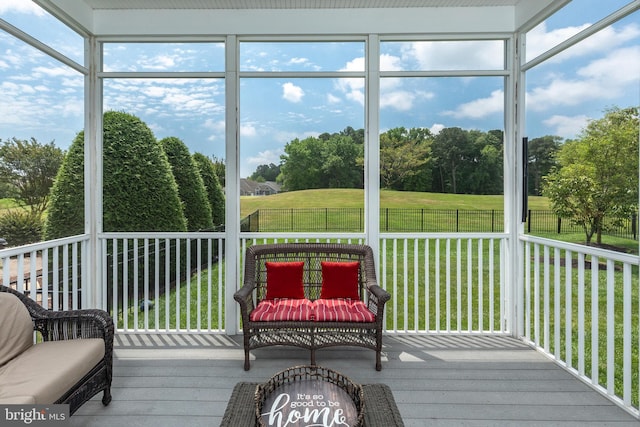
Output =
[{"x1": 224, "y1": 35, "x2": 240, "y2": 335}]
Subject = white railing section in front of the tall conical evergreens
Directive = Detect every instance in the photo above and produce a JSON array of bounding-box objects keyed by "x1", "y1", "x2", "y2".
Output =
[{"x1": 100, "y1": 233, "x2": 225, "y2": 333}]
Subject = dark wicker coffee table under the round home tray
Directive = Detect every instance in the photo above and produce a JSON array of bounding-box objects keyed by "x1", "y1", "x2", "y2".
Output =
[{"x1": 220, "y1": 382, "x2": 404, "y2": 427}]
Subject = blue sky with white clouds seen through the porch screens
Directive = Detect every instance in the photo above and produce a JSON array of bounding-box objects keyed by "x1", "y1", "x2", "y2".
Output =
[{"x1": 0, "y1": 0, "x2": 640, "y2": 176}]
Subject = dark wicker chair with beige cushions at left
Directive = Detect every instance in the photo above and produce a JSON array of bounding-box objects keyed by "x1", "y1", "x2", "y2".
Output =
[{"x1": 0, "y1": 285, "x2": 114, "y2": 415}]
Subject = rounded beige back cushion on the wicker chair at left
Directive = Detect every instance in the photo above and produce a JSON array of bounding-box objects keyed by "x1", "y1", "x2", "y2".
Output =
[{"x1": 0, "y1": 292, "x2": 33, "y2": 366}]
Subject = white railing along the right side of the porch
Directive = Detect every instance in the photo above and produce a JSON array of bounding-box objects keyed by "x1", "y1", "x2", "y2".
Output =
[{"x1": 519, "y1": 236, "x2": 640, "y2": 415}]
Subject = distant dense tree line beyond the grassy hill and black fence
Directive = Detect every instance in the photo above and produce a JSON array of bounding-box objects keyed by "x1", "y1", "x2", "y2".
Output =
[{"x1": 250, "y1": 127, "x2": 562, "y2": 195}]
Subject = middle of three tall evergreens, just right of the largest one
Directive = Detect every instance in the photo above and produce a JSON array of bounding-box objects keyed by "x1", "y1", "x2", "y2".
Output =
[{"x1": 160, "y1": 136, "x2": 213, "y2": 231}]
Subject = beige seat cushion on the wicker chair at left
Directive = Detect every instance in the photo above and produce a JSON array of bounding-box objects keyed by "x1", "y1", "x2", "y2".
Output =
[{"x1": 0, "y1": 338, "x2": 104, "y2": 405}]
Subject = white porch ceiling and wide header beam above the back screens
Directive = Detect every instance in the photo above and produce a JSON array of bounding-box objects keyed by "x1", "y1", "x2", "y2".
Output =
[{"x1": 33, "y1": 0, "x2": 571, "y2": 39}]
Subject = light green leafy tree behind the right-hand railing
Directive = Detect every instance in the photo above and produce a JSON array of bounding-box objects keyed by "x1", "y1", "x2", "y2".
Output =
[{"x1": 543, "y1": 107, "x2": 639, "y2": 244}]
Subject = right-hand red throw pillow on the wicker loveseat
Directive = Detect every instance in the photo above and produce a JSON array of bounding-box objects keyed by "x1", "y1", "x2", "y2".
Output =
[{"x1": 320, "y1": 261, "x2": 360, "y2": 300}]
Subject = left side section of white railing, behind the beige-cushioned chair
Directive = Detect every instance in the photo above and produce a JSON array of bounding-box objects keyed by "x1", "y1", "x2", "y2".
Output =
[{"x1": 0, "y1": 235, "x2": 92, "y2": 310}]
